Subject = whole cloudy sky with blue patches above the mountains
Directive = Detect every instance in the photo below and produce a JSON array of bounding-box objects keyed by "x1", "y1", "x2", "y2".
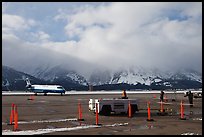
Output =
[{"x1": 2, "y1": 2, "x2": 202, "y2": 76}]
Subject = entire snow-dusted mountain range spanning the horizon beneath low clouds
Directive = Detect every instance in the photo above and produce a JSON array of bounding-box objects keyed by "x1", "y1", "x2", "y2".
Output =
[{"x1": 2, "y1": 66, "x2": 202, "y2": 90}]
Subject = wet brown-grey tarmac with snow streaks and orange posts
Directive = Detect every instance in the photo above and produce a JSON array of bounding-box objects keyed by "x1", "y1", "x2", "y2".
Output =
[{"x1": 2, "y1": 91, "x2": 202, "y2": 135}]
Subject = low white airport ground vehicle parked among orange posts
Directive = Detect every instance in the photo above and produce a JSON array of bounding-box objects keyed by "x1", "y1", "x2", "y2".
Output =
[{"x1": 89, "y1": 98, "x2": 139, "y2": 116}]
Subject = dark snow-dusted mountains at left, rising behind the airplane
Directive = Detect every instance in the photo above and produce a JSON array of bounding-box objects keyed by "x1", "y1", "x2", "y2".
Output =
[{"x1": 2, "y1": 66, "x2": 88, "y2": 90}]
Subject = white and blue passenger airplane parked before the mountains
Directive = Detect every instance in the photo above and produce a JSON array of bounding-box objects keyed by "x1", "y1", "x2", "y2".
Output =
[{"x1": 25, "y1": 78, "x2": 65, "y2": 96}]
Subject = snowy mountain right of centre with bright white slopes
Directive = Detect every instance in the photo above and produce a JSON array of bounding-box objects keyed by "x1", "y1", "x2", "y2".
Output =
[{"x1": 89, "y1": 67, "x2": 202, "y2": 85}]
